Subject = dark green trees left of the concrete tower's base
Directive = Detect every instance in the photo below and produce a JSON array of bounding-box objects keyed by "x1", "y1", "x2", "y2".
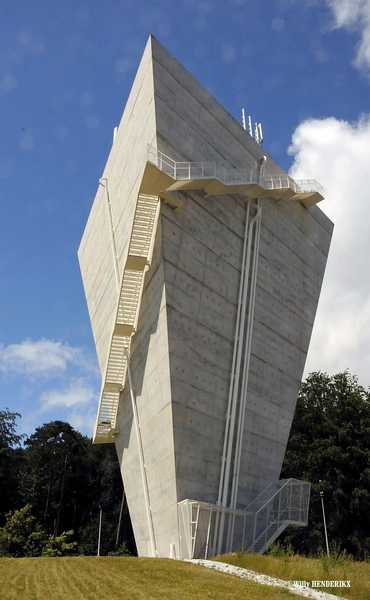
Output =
[{"x1": 0, "y1": 411, "x2": 136, "y2": 556}]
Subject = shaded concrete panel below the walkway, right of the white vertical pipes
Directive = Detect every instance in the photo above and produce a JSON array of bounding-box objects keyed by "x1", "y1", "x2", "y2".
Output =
[{"x1": 238, "y1": 198, "x2": 332, "y2": 508}]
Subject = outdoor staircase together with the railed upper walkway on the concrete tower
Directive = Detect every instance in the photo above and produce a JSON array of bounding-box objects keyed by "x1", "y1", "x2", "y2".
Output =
[{"x1": 93, "y1": 145, "x2": 323, "y2": 443}]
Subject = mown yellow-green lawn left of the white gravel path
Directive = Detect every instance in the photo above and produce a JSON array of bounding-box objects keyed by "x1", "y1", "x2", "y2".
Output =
[{"x1": 0, "y1": 556, "x2": 299, "y2": 600}]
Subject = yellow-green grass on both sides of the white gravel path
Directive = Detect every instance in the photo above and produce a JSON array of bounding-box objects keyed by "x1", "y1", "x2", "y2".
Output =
[{"x1": 0, "y1": 554, "x2": 370, "y2": 600}]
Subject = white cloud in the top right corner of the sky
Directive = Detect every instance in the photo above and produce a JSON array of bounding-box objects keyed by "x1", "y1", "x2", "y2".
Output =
[{"x1": 326, "y1": 0, "x2": 370, "y2": 69}]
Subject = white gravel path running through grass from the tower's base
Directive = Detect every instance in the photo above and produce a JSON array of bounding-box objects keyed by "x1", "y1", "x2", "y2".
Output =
[{"x1": 186, "y1": 558, "x2": 344, "y2": 600}]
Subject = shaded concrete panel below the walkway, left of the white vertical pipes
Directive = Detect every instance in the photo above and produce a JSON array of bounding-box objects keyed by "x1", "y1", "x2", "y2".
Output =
[{"x1": 163, "y1": 192, "x2": 245, "y2": 503}]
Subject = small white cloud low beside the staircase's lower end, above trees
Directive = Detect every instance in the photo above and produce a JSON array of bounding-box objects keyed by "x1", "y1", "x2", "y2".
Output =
[{"x1": 39, "y1": 379, "x2": 96, "y2": 412}]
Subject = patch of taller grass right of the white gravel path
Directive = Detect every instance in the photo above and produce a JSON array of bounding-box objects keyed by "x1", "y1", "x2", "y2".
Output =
[{"x1": 216, "y1": 554, "x2": 370, "y2": 600}]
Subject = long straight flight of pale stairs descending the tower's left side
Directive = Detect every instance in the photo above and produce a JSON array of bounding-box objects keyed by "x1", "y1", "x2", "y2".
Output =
[{"x1": 93, "y1": 194, "x2": 159, "y2": 444}]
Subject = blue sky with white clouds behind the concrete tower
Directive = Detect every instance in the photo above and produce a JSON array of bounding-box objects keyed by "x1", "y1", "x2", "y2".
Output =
[{"x1": 0, "y1": 0, "x2": 370, "y2": 435}]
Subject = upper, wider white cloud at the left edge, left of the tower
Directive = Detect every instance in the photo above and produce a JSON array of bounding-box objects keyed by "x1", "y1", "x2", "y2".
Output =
[{"x1": 0, "y1": 338, "x2": 95, "y2": 376}]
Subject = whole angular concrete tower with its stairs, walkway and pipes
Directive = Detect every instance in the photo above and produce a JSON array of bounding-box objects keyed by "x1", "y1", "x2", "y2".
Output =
[{"x1": 79, "y1": 37, "x2": 333, "y2": 557}]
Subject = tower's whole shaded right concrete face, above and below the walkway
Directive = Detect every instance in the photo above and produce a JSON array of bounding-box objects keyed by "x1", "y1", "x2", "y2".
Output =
[{"x1": 149, "y1": 35, "x2": 332, "y2": 507}]
